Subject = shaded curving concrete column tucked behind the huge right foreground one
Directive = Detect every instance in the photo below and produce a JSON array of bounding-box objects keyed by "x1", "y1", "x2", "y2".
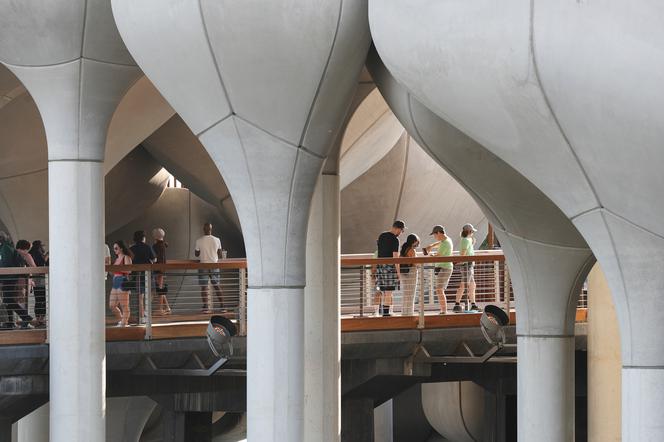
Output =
[{"x1": 368, "y1": 52, "x2": 594, "y2": 441}]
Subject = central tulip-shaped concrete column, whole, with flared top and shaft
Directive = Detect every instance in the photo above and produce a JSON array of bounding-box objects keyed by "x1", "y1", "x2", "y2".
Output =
[{"x1": 113, "y1": 0, "x2": 369, "y2": 442}]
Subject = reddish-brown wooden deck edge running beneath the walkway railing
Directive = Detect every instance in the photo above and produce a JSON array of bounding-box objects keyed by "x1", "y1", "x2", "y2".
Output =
[{"x1": 0, "y1": 309, "x2": 588, "y2": 345}]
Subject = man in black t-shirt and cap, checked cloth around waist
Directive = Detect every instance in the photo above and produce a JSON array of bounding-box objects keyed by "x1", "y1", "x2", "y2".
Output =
[{"x1": 376, "y1": 220, "x2": 406, "y2": 316}]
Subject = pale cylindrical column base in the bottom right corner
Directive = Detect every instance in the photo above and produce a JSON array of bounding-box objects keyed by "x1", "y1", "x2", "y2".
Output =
[{"x1": 622, "y1": 367, "x2": 664, "y2": 442}]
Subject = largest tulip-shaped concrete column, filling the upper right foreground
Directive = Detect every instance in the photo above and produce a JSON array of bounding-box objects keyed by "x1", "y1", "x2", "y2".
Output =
[{"x1": 370, "y1": 0, "x2": 664, "y2": 441}]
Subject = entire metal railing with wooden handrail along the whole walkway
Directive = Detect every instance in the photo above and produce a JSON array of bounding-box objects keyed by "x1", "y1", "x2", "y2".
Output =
[{"x1": 0, "y1": 250, "x2": 587, "y2": 339}]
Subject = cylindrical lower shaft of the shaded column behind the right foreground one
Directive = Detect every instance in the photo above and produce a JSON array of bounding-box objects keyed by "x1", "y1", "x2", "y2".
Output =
[{"x1": 517, "y1": 336, "x2": 574, "y2": 442}]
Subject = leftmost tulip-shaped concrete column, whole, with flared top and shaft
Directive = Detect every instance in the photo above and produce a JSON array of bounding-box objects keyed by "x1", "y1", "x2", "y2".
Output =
[{"x1": 0, "y1": 0, "x2": 139, "y2": 442}]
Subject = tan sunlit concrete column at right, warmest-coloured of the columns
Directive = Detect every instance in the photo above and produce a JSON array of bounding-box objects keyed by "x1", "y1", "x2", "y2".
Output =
[{"x1": 588, "y1": 264, "x2": 622, "y2": 442}]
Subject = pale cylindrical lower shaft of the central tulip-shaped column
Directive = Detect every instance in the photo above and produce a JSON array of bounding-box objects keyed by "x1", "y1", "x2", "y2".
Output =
[{"x1": 247, "y1": 287, "x2": 304, "y2": 442}]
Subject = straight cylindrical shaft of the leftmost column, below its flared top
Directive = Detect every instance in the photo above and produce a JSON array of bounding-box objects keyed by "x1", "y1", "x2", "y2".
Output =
[{"x1": 48, "y1": 160, "x2": 106, "y2": 441}]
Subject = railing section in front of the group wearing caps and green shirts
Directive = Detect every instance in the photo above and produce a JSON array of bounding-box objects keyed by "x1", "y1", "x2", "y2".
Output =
[{"x1": 341, "y1": 251, "x2": 514, "y2": 326}]
